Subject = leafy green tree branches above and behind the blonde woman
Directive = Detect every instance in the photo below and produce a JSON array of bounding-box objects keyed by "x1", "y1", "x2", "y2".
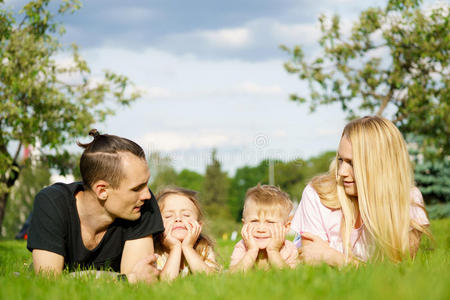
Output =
[{"x1": 282, "y1": 0, "x2": 450, "y2": 158}]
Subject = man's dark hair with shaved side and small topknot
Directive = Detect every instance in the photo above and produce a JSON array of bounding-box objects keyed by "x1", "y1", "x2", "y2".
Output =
[{"x1": 77, "y1": 129, "x2": 145, "y2": 188}]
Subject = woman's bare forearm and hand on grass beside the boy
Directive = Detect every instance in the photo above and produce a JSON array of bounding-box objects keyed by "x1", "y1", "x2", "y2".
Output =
[{"x1": 299, "y1": 232, "x2": 344, "y2": 266}]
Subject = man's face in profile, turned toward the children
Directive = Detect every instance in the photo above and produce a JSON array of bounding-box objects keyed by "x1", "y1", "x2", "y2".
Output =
[{"x1": 105, "y1": 152, "x2": 151, "y2": 220}]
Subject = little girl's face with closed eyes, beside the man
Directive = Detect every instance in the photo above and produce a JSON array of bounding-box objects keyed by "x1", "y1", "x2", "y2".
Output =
[{"x1": 161, "y1": 194, "x2": 198, "y2": 241}]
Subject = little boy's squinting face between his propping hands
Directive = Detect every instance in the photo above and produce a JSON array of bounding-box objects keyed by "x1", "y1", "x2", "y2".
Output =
[{"x1": 242, "y1": 201, "x2": 289, "y2": 249}]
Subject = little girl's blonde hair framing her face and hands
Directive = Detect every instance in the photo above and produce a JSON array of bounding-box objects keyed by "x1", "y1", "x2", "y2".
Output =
[{"x1": 154, "y1": 187, "x2": 216, "y2": 264}]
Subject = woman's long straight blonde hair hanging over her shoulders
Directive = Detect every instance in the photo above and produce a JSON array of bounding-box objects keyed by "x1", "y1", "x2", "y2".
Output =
[{"x1": 312, "y1": 117, "x2": 429, "y2": 262}]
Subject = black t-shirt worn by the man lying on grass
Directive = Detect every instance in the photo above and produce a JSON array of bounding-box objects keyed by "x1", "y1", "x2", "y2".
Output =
[{"x1": 27, "y1": 182, "x2": 164, "y2": 272}]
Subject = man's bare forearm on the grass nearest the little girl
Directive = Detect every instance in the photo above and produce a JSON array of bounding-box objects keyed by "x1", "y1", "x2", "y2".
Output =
[{"x1": 120, "y1": 235, "x2": 159, "y2": 283}]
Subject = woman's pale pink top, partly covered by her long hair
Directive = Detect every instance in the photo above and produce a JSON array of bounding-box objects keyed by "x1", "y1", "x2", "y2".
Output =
[{"x1": 291, "y1": 184, "x2": 430, "y2": 260}]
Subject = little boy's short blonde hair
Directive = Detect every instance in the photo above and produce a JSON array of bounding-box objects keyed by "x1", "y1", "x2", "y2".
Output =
[{"x1": 242, "y1": 184, "x2": 293, "y2": 220}]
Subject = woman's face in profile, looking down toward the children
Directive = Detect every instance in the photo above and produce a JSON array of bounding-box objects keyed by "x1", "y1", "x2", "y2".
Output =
[{"x1": 338, "y1": 136, "x2": 358, "y2": 197}]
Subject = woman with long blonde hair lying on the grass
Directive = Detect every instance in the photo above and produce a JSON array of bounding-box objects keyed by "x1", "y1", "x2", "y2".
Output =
[{"x1": 292, "y1": 117, "x2": 431, "y2": 266}]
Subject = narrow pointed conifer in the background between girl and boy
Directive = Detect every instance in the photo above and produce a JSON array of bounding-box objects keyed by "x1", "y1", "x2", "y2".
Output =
[{"x1": 200, "y1": 149, "x2": 230, "y2": 217}]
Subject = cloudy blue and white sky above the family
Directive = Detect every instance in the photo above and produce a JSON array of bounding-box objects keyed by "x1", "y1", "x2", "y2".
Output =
[{"x1": 5, "y1": 0, "x2": 385, "y2": 174}]
